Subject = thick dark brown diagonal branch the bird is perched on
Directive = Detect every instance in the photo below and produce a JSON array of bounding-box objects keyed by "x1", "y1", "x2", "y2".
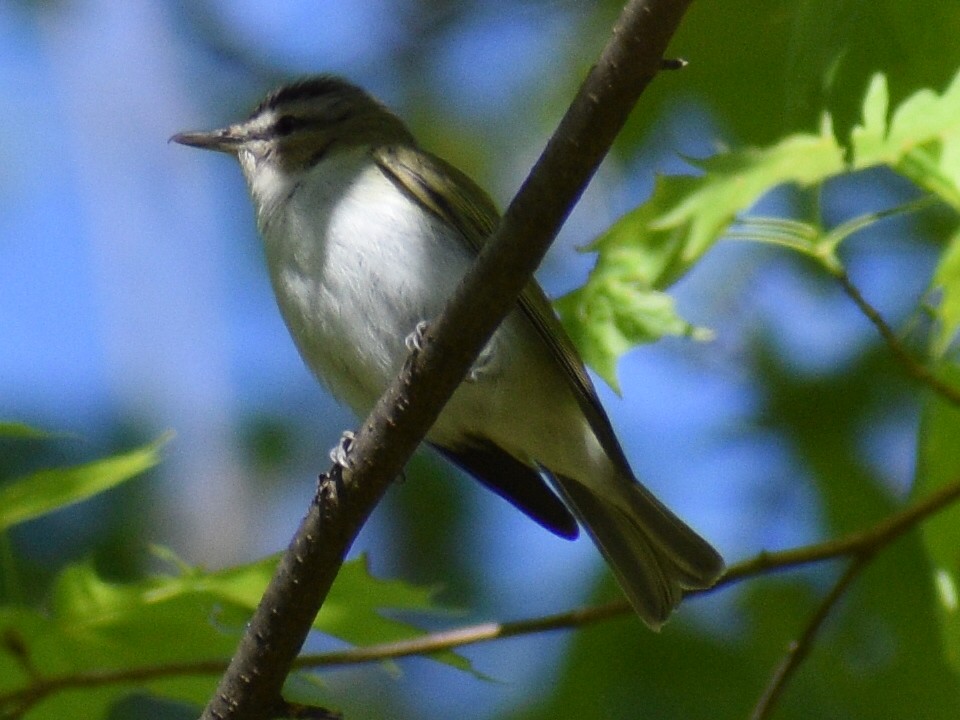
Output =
[{"x1": 202, "y1": 0, "x2": 690, "y2": 720}]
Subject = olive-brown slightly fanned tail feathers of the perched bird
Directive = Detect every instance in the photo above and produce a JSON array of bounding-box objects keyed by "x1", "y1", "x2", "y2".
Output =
[{"x1": 554, "y1": 476, "x2": 723, "y2": 629}]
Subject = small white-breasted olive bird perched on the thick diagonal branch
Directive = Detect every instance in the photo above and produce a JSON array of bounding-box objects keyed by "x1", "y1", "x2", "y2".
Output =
[{"x1": 173, "y1": 76, "x2": 723, "y2": 627}]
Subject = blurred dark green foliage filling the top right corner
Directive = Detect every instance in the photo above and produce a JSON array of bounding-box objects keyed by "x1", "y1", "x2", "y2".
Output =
[{"x1": 598, "y1": 0, "x2": 960, "y2": 144}]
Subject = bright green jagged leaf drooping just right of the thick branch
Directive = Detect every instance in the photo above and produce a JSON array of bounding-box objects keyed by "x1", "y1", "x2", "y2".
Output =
[{"x1": 556, "y1": 116, "x2": 844, "y2": 388}]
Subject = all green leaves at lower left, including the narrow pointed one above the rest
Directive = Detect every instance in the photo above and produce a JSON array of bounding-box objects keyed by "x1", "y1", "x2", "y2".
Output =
[{"x1": 0, "y1": 434, "x2": 456, "y2": 719}]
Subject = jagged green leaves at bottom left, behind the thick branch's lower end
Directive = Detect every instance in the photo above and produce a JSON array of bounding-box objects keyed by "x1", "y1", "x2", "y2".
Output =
[{"x1": 0, "y1": 551, "x2": 462, "y2": 718}]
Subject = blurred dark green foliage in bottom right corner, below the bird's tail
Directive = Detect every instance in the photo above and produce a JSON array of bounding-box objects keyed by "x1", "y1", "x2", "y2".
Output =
[{"x1": 510, "y1": 541, "x2": 960, "y2": 720}]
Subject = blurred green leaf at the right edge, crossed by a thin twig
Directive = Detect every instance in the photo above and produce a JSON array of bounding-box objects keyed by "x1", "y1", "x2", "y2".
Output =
[{"x1": 914, "y1": 365, "x2": 960, "y2": 672}]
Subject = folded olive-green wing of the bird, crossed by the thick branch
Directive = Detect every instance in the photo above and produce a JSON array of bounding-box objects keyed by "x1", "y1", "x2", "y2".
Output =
[{"x1": 374, "y1": 145, "x2": 633, "y2": 477}]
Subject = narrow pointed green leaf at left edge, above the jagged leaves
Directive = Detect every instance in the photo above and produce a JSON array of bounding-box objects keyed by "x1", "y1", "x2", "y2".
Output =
[{"x1": 0, "y1": 436, "x2": 166, "y2": 531}]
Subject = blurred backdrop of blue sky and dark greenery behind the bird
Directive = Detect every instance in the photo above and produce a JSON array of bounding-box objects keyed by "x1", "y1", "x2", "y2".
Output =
[{"x1": 0, "y1": 0, "x2": 958, "y2": 718}]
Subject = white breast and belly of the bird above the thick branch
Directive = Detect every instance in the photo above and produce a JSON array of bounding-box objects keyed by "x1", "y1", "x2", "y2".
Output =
[{"x1": 261, "y1": 151, "x2": 470, "y2": 414}]
